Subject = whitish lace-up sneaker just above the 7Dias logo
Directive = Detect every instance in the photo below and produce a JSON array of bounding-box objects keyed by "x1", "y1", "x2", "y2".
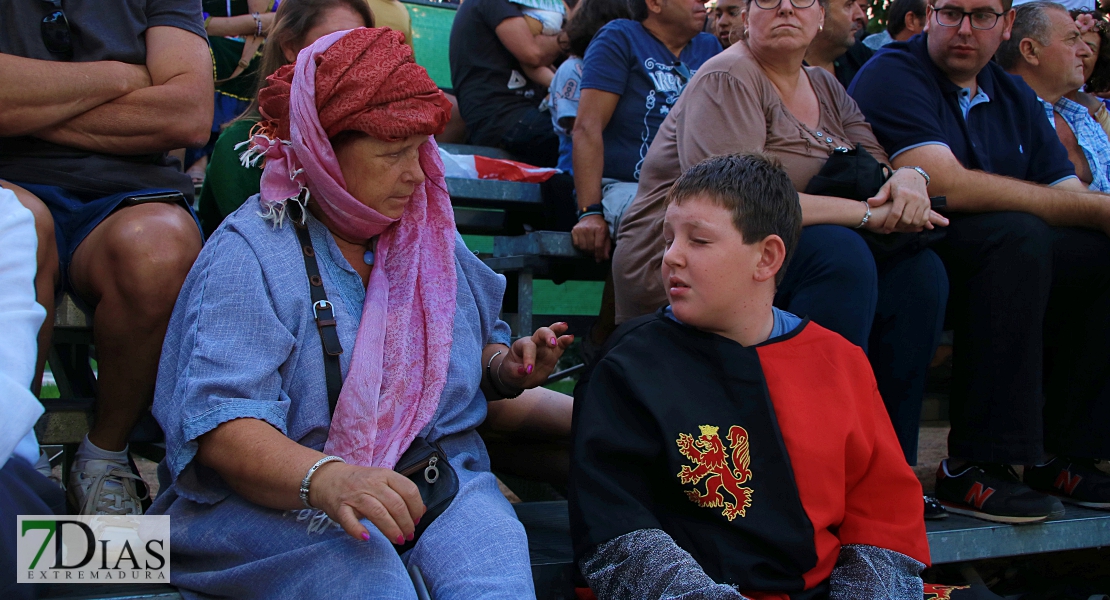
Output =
[{"x1": 69, "y1": 459, "x2": 147, "y2": 515}]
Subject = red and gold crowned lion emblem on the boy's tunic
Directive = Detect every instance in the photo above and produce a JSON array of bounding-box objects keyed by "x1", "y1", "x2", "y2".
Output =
[{"x1": 677, "y1": 425, "x2": 753, "y2": 520}]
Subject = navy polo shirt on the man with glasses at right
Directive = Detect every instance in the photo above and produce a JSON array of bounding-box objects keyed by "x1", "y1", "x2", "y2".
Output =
[{"x1": 848, "y1": 33, "x2": 1076, "y2": 185}]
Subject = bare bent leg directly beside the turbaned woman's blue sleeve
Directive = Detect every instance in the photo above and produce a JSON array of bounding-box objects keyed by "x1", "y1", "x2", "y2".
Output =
[{"x1": 70, "y1": 203, "x2": 201, "y2": 450}]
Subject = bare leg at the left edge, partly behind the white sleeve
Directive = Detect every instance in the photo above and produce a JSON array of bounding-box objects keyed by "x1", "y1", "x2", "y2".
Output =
[{"x1": 0, "y1": 180, "x2": 61, "y2": 396}]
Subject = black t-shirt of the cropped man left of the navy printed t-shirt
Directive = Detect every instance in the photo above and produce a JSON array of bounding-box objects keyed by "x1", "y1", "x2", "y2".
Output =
[{"x1": 451, "y1": 0, "x2": 547, "y2": 145}]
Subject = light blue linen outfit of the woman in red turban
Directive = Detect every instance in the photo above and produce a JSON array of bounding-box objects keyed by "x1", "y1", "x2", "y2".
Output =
[{"x1": 150, "y1": 196, "x2": 535, "y2": 599}]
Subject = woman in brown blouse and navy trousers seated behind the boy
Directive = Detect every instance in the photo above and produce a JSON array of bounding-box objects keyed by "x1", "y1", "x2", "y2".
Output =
[{"x1": 613, "y1": 0, "x2": 948, "y2": 511}]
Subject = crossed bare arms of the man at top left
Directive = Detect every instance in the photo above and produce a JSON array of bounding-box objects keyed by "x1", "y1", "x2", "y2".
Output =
[{"x1": 0, "y1": 27, "x2": 213, "y2": 154}]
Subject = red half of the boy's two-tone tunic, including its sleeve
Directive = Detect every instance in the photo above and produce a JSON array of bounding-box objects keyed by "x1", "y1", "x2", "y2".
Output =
[{"x1": 758, "y1": 323, "x2": 929, "y2": 589}]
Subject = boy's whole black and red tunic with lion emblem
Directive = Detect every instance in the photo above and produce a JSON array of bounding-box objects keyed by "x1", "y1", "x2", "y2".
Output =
[{"x1": 569, "y1": 312, "x2": 929, "y2": 599}]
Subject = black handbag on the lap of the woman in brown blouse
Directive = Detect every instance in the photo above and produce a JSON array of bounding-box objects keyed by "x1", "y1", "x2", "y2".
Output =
[{"x1": 805, "y1": 144, "x2": 946, "y2": 262}]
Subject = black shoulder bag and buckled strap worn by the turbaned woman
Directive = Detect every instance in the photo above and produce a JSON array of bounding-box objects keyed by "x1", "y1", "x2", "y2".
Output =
[{"x1": 293, "y1": 215, "x2": 458, "y2": 553}]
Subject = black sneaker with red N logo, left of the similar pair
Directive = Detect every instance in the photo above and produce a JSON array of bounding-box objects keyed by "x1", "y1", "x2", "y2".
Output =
[{"x1": 936, "y1": 459, "x2": 1063, "y2": 523}]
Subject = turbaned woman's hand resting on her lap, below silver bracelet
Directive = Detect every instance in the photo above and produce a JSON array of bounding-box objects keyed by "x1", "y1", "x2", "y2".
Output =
[{"x1": 309, "y1": 462, "x2": 425, "y2": 546}]
